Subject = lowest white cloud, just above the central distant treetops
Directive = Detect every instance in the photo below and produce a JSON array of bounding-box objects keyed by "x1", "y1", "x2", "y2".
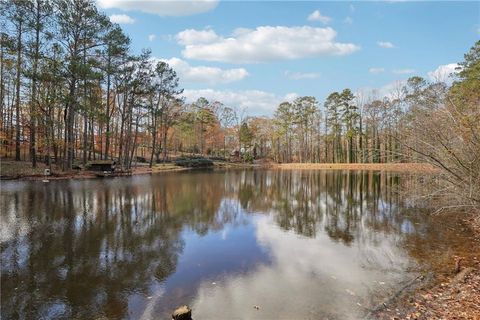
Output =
[{"x1": 183, "y1": 89, "x2": 298, "y2": 115}]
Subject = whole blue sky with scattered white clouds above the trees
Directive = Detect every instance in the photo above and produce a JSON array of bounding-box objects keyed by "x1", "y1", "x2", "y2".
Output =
[{"x1": 98, "y1": 0, "x2": 480, "y2": 115}]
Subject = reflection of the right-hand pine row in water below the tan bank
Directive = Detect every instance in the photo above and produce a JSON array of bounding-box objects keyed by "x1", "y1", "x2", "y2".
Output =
[{"x1": 235, "y1": 170, "x2": 480, "y2": 278}]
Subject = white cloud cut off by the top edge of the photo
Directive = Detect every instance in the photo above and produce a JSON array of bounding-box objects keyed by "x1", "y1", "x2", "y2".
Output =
[{"x1": 97, "y1": 0, "x2": 218, "y2": 16}]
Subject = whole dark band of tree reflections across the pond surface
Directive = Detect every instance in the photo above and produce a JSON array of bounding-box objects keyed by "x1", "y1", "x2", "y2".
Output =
[{"x1": 0, "y1": 170, "x2": 470, "y2": 319}]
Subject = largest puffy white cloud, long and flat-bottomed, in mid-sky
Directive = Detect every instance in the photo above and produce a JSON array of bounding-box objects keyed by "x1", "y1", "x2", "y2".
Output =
[{"x1": 177, "y1": 26, "x2": 359, "y2": 63}]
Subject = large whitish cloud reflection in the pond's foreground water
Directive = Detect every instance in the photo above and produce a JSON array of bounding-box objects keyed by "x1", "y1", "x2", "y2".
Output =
[{"x1": 192, "y1": 216, "x2": 412, "y2": 319}]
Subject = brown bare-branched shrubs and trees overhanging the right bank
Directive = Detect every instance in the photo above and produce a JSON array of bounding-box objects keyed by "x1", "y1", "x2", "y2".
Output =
[{"x1": 404, "y1": 41, "x2": 480, "y2": 218}]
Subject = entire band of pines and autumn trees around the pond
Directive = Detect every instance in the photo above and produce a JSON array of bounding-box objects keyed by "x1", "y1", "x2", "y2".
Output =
[{"x1": 0, "y1": 0, "x2": 480, "y2": 212}]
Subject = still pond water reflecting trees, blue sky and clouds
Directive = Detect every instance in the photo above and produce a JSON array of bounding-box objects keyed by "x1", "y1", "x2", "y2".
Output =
[{"x1": 0, "y1": 170, "x2": 470, "y2": 320}]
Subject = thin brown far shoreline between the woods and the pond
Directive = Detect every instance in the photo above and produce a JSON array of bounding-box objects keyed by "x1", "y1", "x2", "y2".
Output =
[{"x1": 0, "y1": 161, "x2": 438, "y2": 181}]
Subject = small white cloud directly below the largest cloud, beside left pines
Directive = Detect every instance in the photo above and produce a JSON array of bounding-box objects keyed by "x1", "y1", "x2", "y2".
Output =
[{"x1": 163, "y1": 58, "x2": 248, "y2": 85}]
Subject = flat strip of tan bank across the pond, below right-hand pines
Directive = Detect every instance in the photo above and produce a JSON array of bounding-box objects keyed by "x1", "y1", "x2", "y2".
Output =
[{"x1": 270, "y1": 163, "x2": 438, "y2": 173}]
